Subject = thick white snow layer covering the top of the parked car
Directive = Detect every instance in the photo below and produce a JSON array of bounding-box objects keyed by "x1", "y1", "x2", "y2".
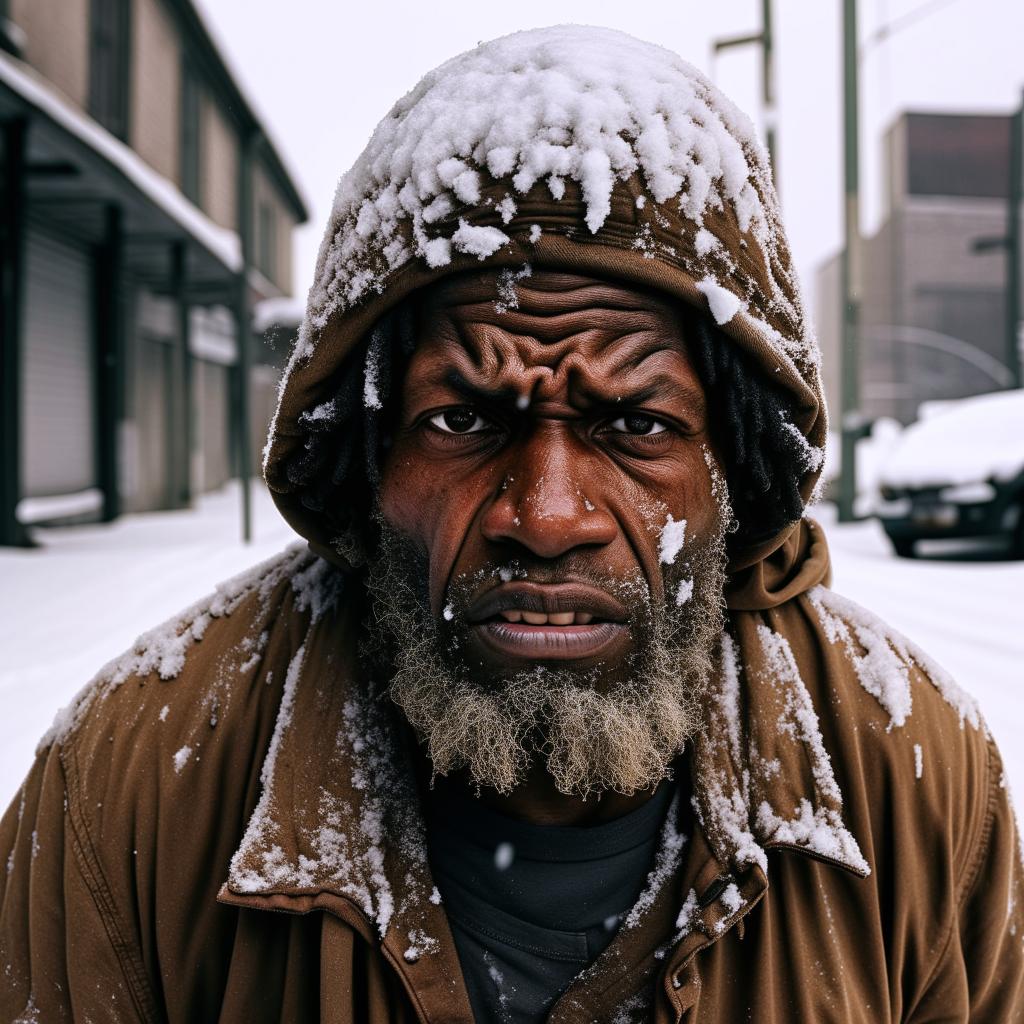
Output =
[{"x1": 882, "y1": 388, "x2": 1024, "y2": 487}]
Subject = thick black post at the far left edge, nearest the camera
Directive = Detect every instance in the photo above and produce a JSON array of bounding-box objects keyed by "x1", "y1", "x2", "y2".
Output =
[{"x1": 0, "y1": 120, "x2": 29, "y2": 546}]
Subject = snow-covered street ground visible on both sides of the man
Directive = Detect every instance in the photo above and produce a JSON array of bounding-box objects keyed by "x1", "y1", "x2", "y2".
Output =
[{"x1": 0, "y1": 487, "x2": 1024, "y2": 810}]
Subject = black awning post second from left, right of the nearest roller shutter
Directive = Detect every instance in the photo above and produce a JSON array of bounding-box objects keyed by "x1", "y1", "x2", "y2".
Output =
[{"x1": 94, "y1": 206, "x2": 125, "y2": 522}]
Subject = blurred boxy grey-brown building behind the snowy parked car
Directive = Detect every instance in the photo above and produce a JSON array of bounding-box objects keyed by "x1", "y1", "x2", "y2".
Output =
[{"x1": 815, "y1": 114, "x2": 1013, "y2": 423}]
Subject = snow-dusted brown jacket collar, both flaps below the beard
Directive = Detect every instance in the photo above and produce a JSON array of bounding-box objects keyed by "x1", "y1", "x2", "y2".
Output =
[{"x1": 219, "y1": 563, "x2": 870, "y2": 942}]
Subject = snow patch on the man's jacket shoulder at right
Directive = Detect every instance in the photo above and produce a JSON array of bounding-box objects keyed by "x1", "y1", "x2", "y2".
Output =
[{"x1": 807, "y1": 587, "x2": 982, "y2": 729}]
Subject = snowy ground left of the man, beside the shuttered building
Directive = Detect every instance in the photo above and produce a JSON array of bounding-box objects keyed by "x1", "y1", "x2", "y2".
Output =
[{"x1": 0, "y1": 484, "x2": 297, "y2": 813}]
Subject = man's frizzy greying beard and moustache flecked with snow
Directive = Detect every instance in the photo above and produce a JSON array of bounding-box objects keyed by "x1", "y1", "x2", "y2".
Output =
[{"x1": 367, "y1": 515, "x2": 726, "y2": 799}]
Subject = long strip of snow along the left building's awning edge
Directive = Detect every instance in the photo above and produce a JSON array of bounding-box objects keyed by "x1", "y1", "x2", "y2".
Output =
[{"x1": 0, "y1": 52, "x2": 242, "y2": 271}]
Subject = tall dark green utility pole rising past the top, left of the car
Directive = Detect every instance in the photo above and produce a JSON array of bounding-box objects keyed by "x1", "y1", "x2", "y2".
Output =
[{"x1": 839, "y1": 0, "x2": 863, "y2": 522}]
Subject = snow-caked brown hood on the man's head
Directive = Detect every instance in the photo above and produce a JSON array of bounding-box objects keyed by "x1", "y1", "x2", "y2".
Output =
[{"x1": 264, "y1": 26, "x2": 826, "y2": 582}]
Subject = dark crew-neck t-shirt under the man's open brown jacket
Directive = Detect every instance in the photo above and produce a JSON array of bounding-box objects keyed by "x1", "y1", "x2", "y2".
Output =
[{"x1": 427, "y1": 782, "x2": 674, "y2": 1024}]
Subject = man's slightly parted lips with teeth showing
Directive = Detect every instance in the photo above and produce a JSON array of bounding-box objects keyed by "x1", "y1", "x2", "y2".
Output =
[{"x1": 467, "y1": 581, "x2": 629, "y2": 662}]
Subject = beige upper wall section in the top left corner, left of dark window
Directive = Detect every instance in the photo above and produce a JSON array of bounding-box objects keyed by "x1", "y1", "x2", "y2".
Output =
[{"x1": 9, "y1": 0, "x2": 89, "y2": 110}]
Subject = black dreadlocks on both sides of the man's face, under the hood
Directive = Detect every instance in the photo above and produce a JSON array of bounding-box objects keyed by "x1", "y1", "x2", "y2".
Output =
[{"x1": 287, "y1": 299, "x2": 821, "y2": 564}]
